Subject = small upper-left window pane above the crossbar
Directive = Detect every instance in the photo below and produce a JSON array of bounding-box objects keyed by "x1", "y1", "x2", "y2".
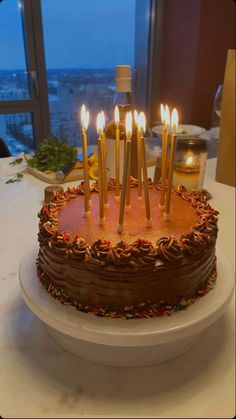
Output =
[{"x1": 0, "y1": 0, "x2": 29, "y2": 101}]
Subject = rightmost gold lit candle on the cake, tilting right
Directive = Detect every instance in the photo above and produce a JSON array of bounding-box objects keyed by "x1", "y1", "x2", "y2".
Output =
[{"x1": 164, "y1": 108, "x2": 179, "y2": 221}]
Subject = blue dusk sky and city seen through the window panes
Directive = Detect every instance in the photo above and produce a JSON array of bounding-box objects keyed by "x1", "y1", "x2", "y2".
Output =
[{"x1": 0, "y1": 0, "x2": 136, "y2": 154}]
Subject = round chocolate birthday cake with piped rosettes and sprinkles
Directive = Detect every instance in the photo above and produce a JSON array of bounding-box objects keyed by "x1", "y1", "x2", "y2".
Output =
[{"x1": 37, "y1": 179, "x2": 218, "y2": 319}]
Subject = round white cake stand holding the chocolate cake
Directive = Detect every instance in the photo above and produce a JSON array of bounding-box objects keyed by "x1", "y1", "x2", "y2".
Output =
[{"x1": 20, "y1": 248, "x2": 234, "y2": 366}]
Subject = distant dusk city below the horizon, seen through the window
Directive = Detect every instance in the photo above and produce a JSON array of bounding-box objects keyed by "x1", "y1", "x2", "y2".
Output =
[{"x1": 0, "y1": 69, "x2": 115, "y2": 154}]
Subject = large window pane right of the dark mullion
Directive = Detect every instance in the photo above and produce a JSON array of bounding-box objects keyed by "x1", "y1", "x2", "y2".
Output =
[{"x1": 42, "y1": 0, "x2": 135, "y2": 145}]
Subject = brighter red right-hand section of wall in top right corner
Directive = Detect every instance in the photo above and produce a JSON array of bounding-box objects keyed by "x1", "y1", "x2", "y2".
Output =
[{"x1": 192, "y1": 0, "x2": 236, "y2": 128}]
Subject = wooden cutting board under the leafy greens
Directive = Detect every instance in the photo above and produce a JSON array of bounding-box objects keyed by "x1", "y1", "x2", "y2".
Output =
[{"x1": 28, "y1": 166, "x2": 84, "y2": 185}]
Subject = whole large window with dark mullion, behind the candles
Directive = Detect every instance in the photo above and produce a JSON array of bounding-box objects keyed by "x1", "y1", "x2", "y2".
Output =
[{"x1": 0, "y1": 0, "x2": 152, "y2": 158}]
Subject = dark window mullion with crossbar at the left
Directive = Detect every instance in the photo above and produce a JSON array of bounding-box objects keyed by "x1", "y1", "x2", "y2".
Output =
[{"x1": 0, "y1": 0, "x2": 50, "y2": 147}]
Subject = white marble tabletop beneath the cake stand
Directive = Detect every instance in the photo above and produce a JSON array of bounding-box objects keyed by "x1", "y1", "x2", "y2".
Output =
[{"x1": 0, "y1": 159, "x2": 235, "y2": 418}]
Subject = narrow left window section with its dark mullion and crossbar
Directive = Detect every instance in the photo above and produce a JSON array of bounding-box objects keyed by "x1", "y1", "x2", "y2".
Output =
[{"x1": 0, "y1": 0, "x2": 50, "y2": 155}]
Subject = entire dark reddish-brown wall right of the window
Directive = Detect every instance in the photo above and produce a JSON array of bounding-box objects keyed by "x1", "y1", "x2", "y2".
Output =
[{"x1": 155, "y1": 0, "x2": 236, "y2": 128}]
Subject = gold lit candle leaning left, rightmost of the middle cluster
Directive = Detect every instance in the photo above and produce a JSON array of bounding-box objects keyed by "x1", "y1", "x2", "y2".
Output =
[{"x1": 138, "y1": 112, "x2": 152, "y2": 227}]
